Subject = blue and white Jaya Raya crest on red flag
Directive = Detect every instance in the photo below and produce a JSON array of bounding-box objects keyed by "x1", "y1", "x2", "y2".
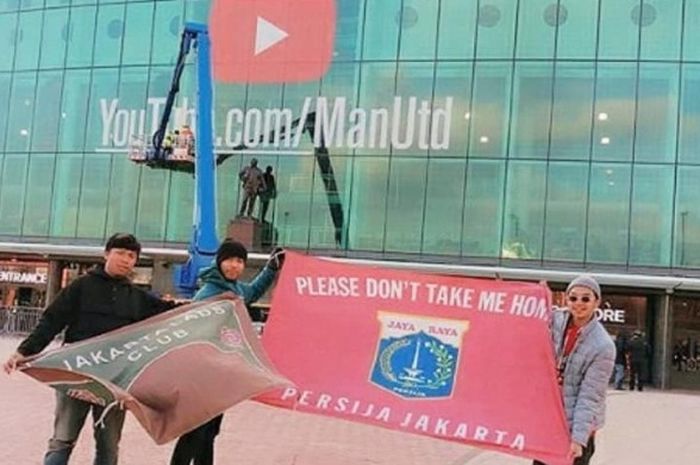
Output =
[{"x1": 370, "y1": 312, "x2": 469, "y2": 399}]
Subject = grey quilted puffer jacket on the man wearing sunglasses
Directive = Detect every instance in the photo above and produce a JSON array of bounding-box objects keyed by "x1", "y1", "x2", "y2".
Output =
[{"x1": 551, "y1": 309, "x2": 615, "y2": 445}]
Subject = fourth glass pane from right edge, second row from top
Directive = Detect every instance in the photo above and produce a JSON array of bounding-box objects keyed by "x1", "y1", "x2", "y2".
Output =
[{"x1": 549, "y1": 62, "x2": 595, "y2": 160}]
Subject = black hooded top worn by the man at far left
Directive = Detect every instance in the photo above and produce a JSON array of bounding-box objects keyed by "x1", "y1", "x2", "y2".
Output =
[{"x1": 17, "y1": 266, "x2": 175, "y2": 356}]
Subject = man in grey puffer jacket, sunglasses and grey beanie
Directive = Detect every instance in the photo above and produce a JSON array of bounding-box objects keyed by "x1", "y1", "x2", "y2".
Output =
[{"x1": 534, "y1": 275, "x2": 615, "y2": 465}]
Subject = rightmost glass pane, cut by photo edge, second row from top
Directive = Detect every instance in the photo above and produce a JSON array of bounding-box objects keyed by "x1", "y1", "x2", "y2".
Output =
[{"x1": 680, "y1": 64, "x2": 700, "y2": 163}]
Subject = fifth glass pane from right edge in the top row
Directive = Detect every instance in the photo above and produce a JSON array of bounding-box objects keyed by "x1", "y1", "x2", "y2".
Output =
[{"x1": 516, "y1": 0, "x2": 552, "y2": 58}]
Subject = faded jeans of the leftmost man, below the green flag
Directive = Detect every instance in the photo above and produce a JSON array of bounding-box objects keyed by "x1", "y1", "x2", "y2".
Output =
[{"x1": 44, "y1": 391, "x2": 125, "y2": 465}]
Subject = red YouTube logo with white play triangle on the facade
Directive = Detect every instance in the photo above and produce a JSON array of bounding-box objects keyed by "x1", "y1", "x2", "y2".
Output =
[{"x1": 209, "y1": 0, "x2": 336, "y2": 83}]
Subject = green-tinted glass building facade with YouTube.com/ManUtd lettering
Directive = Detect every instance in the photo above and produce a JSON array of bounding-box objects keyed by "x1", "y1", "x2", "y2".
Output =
[{"x1": 0, "y1": 0, "x2": 700, "y2": 273}]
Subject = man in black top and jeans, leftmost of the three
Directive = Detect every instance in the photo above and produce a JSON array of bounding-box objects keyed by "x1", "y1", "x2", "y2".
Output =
[{"x1": 3, "y1": 234, "x2": 175, "y2": 465}]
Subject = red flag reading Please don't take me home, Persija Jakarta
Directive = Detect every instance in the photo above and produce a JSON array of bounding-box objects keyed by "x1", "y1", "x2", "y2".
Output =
[{"x1": 258, "y1": 253, "x2": 571, "y2": 465}]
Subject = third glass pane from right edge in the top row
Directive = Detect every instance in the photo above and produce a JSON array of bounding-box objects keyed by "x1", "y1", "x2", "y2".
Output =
[{"x1": 598, "y1": 0, "x2": 650, "y2": 59}]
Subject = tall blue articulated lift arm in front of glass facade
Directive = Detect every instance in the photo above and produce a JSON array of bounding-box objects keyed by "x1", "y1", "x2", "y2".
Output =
[{"x1": 166, "y1": 23, "x2": 219, "y2": 297}]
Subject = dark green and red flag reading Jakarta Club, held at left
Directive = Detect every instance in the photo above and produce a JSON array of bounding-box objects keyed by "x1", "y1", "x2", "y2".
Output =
[{"x1": 22, "y1": 294, "x2": 289, "y2": 444}]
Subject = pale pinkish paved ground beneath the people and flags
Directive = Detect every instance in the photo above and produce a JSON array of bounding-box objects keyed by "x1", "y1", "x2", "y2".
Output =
[{"x1": 0, "y1": 338, "x2": 700, "y2": 465}]
